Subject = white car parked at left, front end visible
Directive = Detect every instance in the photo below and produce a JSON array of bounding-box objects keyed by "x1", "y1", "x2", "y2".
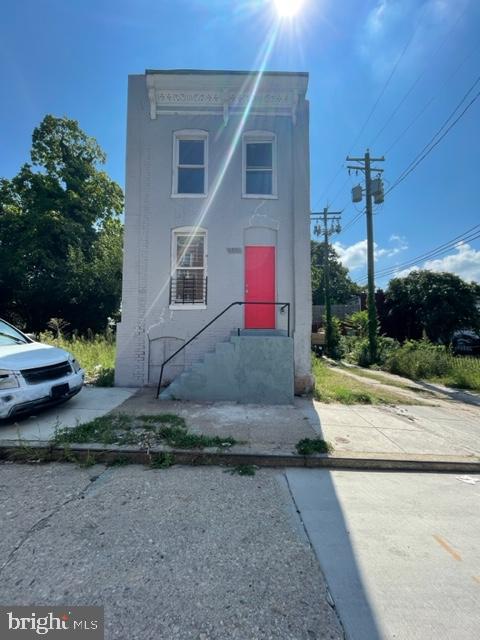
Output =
[{"x1": 0, "y1": 319, "x2": 85, "y2": 420}]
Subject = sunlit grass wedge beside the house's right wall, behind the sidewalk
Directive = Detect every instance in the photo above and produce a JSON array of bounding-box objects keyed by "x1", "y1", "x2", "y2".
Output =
[{"x1": 312, "y1": 356, "x2": 422, "y2": 404}]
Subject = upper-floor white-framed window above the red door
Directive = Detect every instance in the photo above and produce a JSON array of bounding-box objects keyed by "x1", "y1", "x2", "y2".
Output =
[{"x1": 243, "y1": 131, "x2": 277, "y2": 198}]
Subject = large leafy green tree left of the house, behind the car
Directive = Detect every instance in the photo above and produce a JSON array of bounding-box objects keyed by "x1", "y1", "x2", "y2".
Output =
[{"x1": 0, "y1": 115, "x2": 123, "y2": 331}]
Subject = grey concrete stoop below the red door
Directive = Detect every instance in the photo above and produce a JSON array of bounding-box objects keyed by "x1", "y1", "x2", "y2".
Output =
[{"x1": 160, "y1": 332, "x2": 294, "y2": 404}]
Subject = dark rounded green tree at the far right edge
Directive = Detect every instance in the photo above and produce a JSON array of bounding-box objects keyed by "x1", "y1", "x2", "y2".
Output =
[{"x1": 382, "y1": 270, "x2": 480, "y2": 345}]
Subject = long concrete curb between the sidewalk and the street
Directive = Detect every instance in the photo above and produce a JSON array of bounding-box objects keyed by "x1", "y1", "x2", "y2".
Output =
[{"x1": 0, "y1": 440, "x2": 480, "y2": 473}]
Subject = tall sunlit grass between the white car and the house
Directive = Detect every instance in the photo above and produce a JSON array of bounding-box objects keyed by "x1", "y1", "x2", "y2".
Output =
[{"x1": 37, "y1": 331, "x2": 115, "y2": 387}]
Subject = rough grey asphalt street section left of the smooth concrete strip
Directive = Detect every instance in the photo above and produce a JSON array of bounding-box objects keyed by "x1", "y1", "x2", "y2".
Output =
[{"x1": 0, "y1": 464, "x2": 343, "y2": 640}]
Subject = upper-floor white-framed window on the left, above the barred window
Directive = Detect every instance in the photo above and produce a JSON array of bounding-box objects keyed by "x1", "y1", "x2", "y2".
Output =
[{"x1": 172, "y1": 130, "x2": 208, "y2": 197}]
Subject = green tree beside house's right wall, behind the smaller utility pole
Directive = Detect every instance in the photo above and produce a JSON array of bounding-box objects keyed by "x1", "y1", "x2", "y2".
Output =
[{"x1": 311, "y1": 240, "x2": 362, "y2": 304}]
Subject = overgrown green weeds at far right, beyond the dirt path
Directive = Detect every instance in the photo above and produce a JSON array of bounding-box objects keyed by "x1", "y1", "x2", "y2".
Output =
[{"x1": 383, "y1": 340, "x2": 480, "y2": 391}]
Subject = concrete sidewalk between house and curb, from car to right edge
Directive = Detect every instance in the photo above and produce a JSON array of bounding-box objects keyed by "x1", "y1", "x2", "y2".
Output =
[{"x1": 0, "y1": 388, "x2": 480, "y2": 471}]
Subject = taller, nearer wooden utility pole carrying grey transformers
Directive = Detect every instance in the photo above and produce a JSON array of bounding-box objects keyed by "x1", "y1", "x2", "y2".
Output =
[{"x1": 347, "y1": 149, "x2": 385, "y2": 363}]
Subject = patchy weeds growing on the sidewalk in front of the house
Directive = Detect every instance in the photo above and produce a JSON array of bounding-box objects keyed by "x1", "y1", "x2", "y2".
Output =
[{"x1": 52, "y1": 413, "x2": 237, "y2": 450}]
